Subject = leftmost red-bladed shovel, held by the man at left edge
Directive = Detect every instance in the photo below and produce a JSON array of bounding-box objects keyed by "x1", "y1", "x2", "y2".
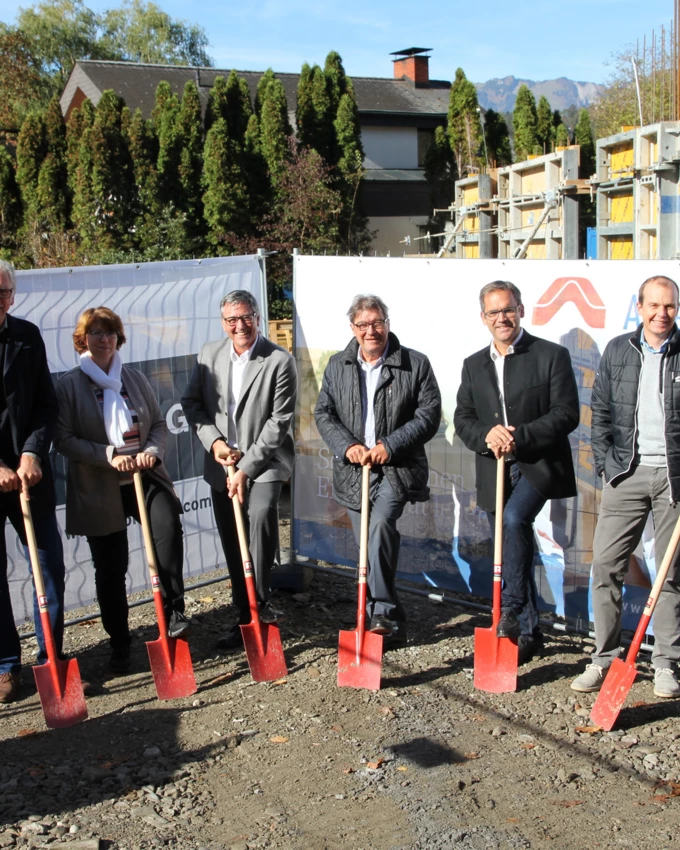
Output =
[{"x1": 19, "y1": 493, "x2": 87, "y2": 729}]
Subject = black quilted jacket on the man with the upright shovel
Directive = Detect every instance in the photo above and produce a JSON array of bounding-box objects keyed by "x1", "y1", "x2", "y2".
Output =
[{"x1": 314, "y1": 333, "x2": 441, "y2": 510}]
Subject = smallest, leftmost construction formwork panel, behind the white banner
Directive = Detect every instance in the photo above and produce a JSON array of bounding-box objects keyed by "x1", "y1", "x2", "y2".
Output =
[{"x1": 453, "y1": 169, "x2": 498, "y2": 260}]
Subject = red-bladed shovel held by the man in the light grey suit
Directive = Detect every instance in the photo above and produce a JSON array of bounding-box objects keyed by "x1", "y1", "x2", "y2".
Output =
[{"x1": 227, "y1": 466, "x2": 288, "y2": 682}]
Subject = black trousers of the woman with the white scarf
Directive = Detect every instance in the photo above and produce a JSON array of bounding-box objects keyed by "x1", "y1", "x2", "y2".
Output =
[{"x1": 87, "y1": 475, "x2": 184, "y2": 648}]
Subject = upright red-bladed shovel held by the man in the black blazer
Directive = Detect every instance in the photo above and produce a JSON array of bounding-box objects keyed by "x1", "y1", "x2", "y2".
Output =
[{"x1": 474, "y1": 456, "x2": 519, "y2": 694}]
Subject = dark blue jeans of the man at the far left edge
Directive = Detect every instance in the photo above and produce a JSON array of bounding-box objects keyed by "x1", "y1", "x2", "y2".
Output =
[{"x1": 0, "y1": 493, "x2": 65, "y2": 673}]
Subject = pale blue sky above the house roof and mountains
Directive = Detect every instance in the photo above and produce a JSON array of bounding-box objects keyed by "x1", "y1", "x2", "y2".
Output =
[{"x1": 0, "y1": 0, "x2": 673, "y2": 83}]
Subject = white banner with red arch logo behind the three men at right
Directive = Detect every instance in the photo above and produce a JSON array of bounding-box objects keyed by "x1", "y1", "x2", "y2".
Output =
[{"x1": 293, "y1": 256, "x2": 680, "y2": 627}]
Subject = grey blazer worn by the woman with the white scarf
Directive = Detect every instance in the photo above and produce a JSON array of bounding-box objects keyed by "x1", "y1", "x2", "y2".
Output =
[{"x1": 54, "y1": 366, "x2": 181, "y2": 537}]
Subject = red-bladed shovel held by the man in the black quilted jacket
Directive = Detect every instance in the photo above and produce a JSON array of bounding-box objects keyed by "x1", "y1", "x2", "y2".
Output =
[{"x1": 338, "y1": 466, "x2": 383, "y2": 691}]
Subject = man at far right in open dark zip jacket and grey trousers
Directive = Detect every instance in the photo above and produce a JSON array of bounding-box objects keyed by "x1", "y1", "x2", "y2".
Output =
[{"x1": 571, "y1": 276, "x2": 680, "y2": 697}]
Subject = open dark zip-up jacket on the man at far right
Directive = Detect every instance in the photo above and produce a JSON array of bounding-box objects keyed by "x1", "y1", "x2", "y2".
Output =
[{"x1": 590, "y1": 325, "x2": 680, "y2": 502}]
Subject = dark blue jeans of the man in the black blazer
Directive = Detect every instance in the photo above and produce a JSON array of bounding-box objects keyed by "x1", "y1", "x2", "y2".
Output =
[{"x1": 489, "y1": 463, "x2": 546, "y2": 635}]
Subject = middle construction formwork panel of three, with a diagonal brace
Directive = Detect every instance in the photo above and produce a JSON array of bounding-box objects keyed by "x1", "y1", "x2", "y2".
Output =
[{"x1": 496, "y1": 145, "x2": 580, "y2": 260}]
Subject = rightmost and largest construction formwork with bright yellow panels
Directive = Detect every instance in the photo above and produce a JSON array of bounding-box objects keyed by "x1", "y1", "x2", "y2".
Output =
[{"x1": 591, "y1": 121, "x2": 680, "y2": 260}]
